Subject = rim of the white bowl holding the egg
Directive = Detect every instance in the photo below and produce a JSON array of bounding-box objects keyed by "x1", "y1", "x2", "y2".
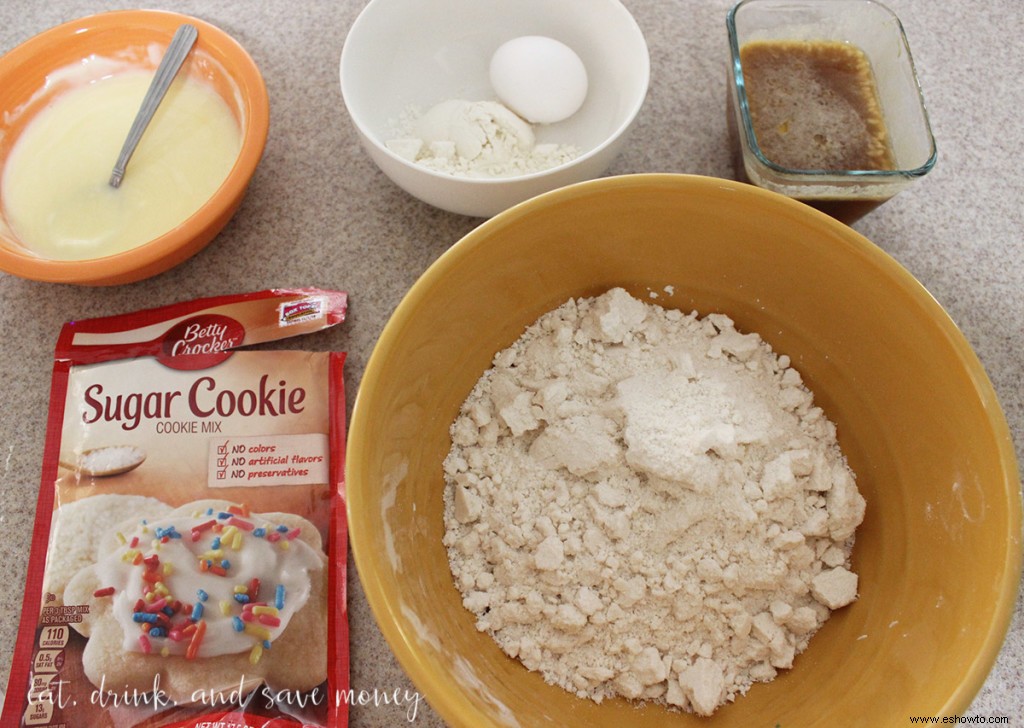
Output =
[{"x1": 339, "y1": 0, "x2": 650, "y2": 186}]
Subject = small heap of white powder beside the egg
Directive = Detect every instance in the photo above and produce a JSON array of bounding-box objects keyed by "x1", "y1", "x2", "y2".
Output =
[{"x1": 385, "y1": 99, "x2": 580, "y2": 178}]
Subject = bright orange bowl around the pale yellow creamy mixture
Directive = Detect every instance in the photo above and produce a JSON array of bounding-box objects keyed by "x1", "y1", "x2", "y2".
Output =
[{"x1": 0, "y1": 10, "x2": 269, "y2": 286}]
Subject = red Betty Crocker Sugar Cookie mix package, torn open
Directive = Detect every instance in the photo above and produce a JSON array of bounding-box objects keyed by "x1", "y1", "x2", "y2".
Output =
[{"x1": 3, "y1": 289, "x2": 348, "y2": 728}]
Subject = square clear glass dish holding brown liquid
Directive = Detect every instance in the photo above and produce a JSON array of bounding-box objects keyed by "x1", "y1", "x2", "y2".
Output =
[{"x1": 726, "y1": 0, "x2": 937, "y2": 222}]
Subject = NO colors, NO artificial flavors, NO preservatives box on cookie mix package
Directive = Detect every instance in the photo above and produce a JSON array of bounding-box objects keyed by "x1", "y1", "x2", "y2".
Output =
[{"x1": 208, "y1": 433, "x2": 330, "y2": 487}]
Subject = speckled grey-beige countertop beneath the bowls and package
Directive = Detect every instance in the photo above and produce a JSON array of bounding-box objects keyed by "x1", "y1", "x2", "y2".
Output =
[{"x1": 0, "y1": 0, "x2": 1024, "y2": 726}]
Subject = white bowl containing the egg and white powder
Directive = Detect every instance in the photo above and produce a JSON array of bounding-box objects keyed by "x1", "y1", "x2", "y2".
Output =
[{"x1": 341, "y1": 0, "x2": 650, "y2": 217}]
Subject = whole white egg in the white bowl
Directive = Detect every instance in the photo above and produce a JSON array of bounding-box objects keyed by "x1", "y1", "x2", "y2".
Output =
[{"x1": 490, "y1": 36, "x2": 587, "y2": 124}]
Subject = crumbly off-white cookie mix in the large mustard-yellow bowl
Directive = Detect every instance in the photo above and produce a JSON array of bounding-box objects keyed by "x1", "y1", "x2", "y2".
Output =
[{"x1": 444, "y1": 289, "x2": 865, "y2": 715}]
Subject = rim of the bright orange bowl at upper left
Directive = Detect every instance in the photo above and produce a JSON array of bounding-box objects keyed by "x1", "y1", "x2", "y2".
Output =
[{"x1": 0, "y1": 9, "x2": 270, "y2": 285}]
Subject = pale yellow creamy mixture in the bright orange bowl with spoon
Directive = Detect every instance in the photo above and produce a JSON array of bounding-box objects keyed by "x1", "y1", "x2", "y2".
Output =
[{"x1": 2, "y1": 70, "x2": 242, "y2": 260}]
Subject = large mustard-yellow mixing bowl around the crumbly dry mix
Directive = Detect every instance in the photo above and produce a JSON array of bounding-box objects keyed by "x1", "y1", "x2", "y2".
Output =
[{"x1": 346, "y1": 175, "x2": 1021, "y2": 728}]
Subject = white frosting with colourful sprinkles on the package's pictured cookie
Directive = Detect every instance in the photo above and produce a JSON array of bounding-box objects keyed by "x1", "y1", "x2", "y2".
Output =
[{"x1": 93, "y1": 505, "x2": 323, "y2": 665}]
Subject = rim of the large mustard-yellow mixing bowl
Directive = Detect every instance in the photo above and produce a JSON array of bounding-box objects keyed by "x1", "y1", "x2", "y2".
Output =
[{"x1": 345, "y1": 173, "x2": 1024, "y2": 725}]
